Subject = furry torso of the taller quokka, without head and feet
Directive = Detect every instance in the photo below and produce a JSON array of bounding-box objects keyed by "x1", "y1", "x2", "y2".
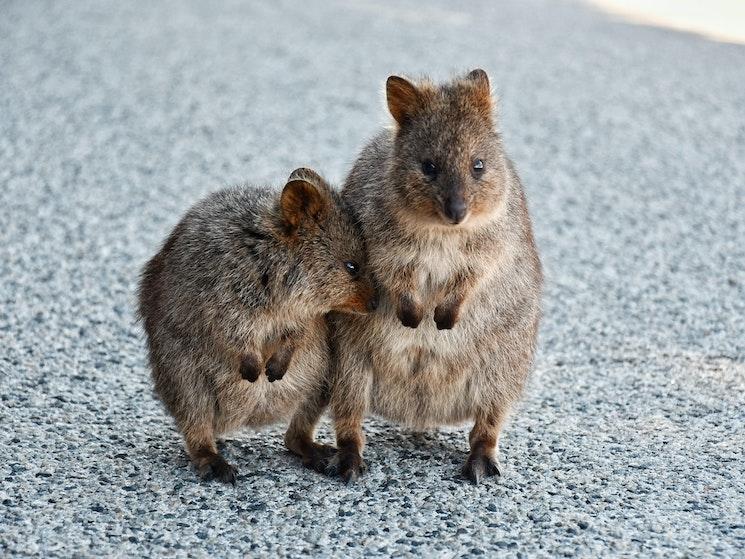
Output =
[{"x1": 335, "y1": 133, "x2": 541, "y2": 427}]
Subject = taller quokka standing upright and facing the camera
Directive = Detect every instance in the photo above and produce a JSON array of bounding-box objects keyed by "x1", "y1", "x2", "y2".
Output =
[{"x1": 294, "y1": 70, "x2": 542, "y2": 483}]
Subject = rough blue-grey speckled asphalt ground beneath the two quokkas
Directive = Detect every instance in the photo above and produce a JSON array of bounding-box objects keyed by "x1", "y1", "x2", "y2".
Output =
[{"x1": 0, "y1": 0, "x2": 745, "y2": 557}]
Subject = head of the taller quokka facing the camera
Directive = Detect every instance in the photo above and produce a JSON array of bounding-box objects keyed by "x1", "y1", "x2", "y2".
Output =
[{"x1": 386, "y1": 70, "x2": 505, "y2": 227}]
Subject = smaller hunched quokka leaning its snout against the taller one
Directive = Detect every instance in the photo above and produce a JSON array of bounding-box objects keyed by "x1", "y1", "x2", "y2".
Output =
[{"x1": 139, "y1": 169, "x2": 377, "y2": 483}]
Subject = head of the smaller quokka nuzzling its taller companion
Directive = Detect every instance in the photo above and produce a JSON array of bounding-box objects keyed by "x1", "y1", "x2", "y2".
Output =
[{"x1": 280, "y1": 168, "x2": 378, "y2": 313}]
